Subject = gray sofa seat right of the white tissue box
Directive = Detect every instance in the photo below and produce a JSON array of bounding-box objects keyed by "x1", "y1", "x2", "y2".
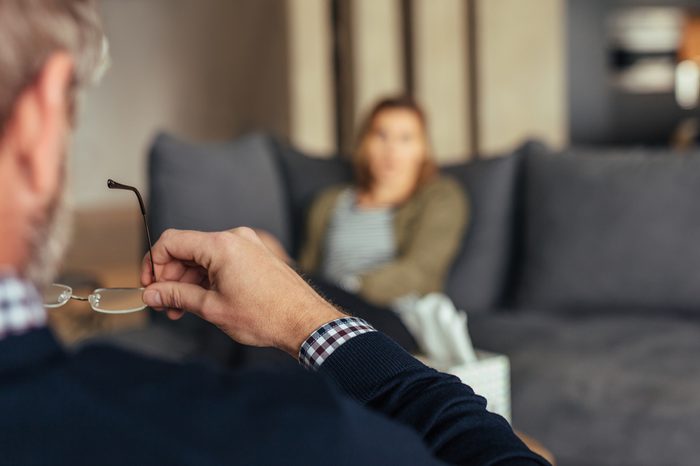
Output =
[{"x1": 469, "y1": 309, "x2": 700, "y2": 466}]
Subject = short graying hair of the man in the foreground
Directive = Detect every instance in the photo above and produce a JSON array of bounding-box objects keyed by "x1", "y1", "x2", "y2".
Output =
[{"x1": 0, "y1": 0, "x2": 106, "y2": 132}]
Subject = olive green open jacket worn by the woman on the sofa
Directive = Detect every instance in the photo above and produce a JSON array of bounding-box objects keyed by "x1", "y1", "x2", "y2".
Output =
[{"x1": 299, "y1": 177, "x2": 469, "y2": 305}]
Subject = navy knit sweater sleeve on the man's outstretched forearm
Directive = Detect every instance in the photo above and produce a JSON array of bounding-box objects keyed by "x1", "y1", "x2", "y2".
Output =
[{"x1": 319, "y1": 332, "x2": 549, "y2": 466}]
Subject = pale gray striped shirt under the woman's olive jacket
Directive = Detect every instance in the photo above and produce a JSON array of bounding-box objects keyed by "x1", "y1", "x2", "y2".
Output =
[{"x1": 320, "y1": 189, "x2": 397, "y2": 291}]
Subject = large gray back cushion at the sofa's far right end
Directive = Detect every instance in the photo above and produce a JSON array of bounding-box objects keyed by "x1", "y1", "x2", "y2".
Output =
[{"x1": 518, "y1": 152, "x2": 700, "y2": 312}]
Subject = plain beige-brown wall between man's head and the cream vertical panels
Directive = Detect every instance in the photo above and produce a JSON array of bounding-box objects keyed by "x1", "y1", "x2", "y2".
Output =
[{"x1": 70, "y1": 0, "x2": 289, "y2": 208}]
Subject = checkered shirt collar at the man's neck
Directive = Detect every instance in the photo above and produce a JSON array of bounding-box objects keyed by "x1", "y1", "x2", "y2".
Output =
[{"x1": 0, "y1": 276, "x2": 46, "y2": 340}]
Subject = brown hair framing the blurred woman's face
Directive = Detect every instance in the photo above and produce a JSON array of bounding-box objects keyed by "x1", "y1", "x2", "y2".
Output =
[{"x1": 352, "y1": 95, "x2": 437, "y2": 190}]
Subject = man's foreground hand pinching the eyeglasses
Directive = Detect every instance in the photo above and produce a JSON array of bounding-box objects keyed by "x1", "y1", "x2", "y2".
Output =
[{"x1": 141, "y1": 228, "x2": 343, "y2": 357}]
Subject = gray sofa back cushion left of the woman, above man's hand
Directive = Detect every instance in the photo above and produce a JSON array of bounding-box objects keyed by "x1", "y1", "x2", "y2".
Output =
[{"x1": 149, "y1": 134, "x2": 291, "y2": 248}]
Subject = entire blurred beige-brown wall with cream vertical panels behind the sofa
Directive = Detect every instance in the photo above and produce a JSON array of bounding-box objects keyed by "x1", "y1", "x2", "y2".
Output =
[{"x1": 71, "y1": 0, "x2": 567, "y2": 208}]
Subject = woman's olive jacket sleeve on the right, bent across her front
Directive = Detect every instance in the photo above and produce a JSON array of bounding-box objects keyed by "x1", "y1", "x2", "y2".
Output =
[{"x1": 359, "y1": 179, "x2": 469, "y2": 305}]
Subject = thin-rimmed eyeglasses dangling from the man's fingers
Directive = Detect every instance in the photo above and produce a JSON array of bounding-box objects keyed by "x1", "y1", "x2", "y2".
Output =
[{"x1": 43, "y1": 180, "x2": 156, "y2": 314}]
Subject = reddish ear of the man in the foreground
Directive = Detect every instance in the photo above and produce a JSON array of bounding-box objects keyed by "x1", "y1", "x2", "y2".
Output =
[{"x1": 10, "y1": 52, "x2": 73, "y2": 204}]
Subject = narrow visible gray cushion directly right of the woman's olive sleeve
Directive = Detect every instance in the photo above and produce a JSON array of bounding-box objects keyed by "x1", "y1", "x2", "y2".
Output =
[{"x1": 444, "y1": 152, "x2": 520, "y2": 312}]
